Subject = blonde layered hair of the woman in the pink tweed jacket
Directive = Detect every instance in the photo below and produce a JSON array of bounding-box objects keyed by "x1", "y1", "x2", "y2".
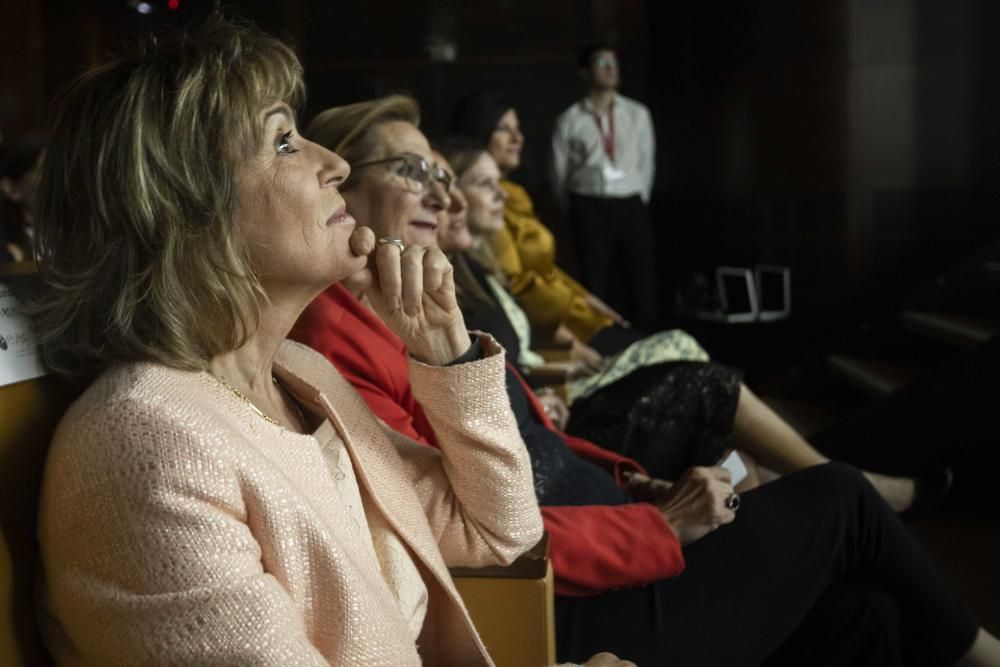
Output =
[{"x1": 33, "y1": 18, "x2": 304, "y2": 378}]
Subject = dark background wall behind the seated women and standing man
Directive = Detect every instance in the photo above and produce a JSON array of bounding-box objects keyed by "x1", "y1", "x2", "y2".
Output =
[{"x1": 0, "y1": 0, "x2": 1000, "y2": 368}]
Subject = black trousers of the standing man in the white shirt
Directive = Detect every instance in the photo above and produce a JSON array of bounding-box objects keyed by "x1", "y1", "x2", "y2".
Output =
[{"x1": 569, "y1": 194, "x2": 659, "y2": 328}]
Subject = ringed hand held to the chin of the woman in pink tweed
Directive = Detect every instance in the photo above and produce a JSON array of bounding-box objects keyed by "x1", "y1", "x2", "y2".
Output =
[{"x1": 365, "y1": 243, "x2": 470, "y2": 366}]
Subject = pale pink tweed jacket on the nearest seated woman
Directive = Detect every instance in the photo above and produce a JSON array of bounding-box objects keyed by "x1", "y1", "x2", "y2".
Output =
[{"x1": 39, "y1": 338, "x2": 542, "y2": 667}]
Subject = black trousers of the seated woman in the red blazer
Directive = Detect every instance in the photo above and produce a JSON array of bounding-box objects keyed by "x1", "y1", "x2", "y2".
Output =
[{"x1": 556, "y1": 463, "x2": 978, "y2": 667}]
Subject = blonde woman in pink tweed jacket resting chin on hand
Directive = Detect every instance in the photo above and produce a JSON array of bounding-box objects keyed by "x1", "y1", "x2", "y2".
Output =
[{"x1": 23, "y1": 19, "x2": 617, "y2": 667}]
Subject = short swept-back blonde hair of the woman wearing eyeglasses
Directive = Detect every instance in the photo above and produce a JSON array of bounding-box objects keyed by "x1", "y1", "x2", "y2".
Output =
[{"x1": 305, "y1": 95, "x2": 420, "y2": 184}]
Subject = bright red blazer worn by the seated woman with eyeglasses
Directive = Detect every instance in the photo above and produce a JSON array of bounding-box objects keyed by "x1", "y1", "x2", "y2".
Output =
[{"x1": 289, "y1": 284, "x2": 684, "y2": 596}]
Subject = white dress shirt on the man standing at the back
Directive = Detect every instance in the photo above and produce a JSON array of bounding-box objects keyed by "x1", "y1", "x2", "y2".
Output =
[{"x1": 552, "y1": 94, "x2": 656, "y2": 207}]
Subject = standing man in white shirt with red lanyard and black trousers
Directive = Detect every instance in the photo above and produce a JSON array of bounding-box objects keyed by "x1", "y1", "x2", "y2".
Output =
[{"x1": 552, "y1": 44, "x2": 658, "y2": 328}]
